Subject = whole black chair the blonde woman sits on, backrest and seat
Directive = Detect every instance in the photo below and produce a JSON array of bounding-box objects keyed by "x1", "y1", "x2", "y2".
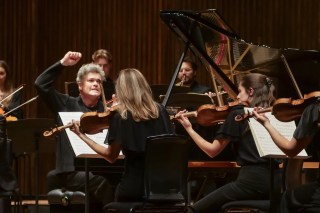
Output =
[{"x1": 104, "y1": 135, "x2": 188, "y2": 213}]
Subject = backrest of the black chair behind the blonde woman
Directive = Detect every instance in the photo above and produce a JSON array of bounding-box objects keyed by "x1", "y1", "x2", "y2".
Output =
[{"x1": 145, "y1": 134, "x2": 188, "y2": 202}]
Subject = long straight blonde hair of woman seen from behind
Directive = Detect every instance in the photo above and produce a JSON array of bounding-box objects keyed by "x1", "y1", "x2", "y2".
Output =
[{"x1": 115, "y1": 68, "x2": 159, "y2": 122}]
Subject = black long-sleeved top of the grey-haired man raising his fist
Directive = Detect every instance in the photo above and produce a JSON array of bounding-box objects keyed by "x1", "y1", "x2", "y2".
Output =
[{"x1": 35, "y1": 61, "x2": 104, "y2": 173}]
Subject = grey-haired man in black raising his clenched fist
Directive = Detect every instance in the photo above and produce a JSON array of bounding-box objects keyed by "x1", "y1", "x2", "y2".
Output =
[{"x1": 35, "y1": 51, "x2": 113, "y2": 210}]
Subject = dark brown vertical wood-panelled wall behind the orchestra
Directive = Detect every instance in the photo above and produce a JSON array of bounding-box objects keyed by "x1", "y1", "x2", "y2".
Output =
[{"x1": 0, "y1": 0, "x2": 320, "y2": 196}]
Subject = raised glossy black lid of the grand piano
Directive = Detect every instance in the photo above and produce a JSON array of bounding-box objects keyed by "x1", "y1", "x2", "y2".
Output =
[{"x1": 160, "y1": 9, "x2": 320, "y2": 98}]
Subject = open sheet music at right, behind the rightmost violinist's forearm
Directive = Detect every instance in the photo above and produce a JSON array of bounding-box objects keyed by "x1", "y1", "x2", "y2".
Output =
[{"x1": 245, "y1": 108, "x2": 308, "y2": 158}]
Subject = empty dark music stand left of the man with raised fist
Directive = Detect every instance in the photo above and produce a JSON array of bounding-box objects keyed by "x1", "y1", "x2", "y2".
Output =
[{"x1": 7, "y1": 118, "x2": 56, "y2": 212}]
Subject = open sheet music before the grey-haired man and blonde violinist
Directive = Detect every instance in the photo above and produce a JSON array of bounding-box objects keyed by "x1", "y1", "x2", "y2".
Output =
[{"x1": 59, "y1": 112, "x2": 108, "y2": 158}]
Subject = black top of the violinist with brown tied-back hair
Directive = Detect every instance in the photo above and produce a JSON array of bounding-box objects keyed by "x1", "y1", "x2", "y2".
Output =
[{"x1": 215, "y1": 106, "x2": 268, "y2": 166}]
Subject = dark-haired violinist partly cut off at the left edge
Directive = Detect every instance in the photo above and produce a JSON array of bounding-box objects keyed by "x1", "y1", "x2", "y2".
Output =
[{"x1": 0, "y1": 60, "x2": 23, "y2": 119}]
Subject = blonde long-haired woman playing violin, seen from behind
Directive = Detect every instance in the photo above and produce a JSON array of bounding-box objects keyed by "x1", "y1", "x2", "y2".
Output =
[{"x1": 71, "y1": 68, "x2": 174, "y2": 205}]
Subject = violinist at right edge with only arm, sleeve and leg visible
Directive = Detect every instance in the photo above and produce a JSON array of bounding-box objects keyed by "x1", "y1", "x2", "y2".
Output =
[{"x1": 253, "y1": 102, "x2": 320, "y2": 213}]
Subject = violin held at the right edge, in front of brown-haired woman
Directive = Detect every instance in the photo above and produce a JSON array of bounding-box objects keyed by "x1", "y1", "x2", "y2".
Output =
[{"x1": 235, "y1": 91, "x2": 320, "y2": 122}]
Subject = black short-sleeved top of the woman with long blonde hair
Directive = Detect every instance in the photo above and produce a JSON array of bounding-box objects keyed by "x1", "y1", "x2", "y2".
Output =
[{"x1": 107, "y1": 105, "x2": 174, "y2": 201}]
